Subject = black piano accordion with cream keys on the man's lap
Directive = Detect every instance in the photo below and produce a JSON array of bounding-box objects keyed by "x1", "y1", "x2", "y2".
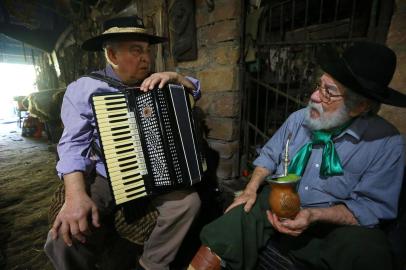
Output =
[{"x1": 91, "y1": 84, "x2": 202, "y2": 204}]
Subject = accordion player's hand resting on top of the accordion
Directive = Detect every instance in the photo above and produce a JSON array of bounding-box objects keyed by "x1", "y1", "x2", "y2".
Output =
[{"x1": 140, "y1": 71, "x2": 195, "y2": 92}]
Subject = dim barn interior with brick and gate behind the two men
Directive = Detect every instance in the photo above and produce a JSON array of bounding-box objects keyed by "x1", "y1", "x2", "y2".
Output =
[{"x1": 0, "y1": 0, "x2": 406, "y2": 270}]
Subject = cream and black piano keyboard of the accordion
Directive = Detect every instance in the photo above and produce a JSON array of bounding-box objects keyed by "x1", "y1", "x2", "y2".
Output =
[{"x1": 93, "y1": 93, "x2": 147, "y2": 204}]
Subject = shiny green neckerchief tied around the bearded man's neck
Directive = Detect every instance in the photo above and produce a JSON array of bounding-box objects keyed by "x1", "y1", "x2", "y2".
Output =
[{"x1": 288, "y1": 119, "x2": 354, "y2": 176}]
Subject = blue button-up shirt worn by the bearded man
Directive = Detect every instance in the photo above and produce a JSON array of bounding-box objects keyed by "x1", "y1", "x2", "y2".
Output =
[{"x1": 254, "y1": 109, "x2": 405, "y2": 227}]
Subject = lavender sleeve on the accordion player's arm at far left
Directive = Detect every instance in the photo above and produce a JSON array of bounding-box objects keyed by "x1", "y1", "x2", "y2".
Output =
[{"x1": 56, "y1": 79, "x2": 94, "y2": 178}]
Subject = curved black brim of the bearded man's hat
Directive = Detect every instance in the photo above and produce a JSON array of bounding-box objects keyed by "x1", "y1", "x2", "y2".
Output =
[{"x1": 316, "y1": 47, "x2": 406, "y2": 107}]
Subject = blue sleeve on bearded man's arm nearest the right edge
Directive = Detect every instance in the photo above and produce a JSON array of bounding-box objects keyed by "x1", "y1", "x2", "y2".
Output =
[{"x1": 343, "y1": 136, "x2": 405, "y2": 227}]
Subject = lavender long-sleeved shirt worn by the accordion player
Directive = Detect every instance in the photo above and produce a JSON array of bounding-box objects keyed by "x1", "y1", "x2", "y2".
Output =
[{"x1": 56, "y1": 65, "x2": 201, "y2": 178}]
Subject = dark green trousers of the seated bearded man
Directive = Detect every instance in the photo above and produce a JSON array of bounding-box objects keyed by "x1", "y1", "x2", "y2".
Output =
[{"x1": 201, "y1": 187, "x2": 392, "y2": 270}]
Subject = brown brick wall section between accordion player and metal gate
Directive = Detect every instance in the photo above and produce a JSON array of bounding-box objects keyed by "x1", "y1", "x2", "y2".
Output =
[{"x1": 186, "y1": 0, "x2": 241, "y2": 183}]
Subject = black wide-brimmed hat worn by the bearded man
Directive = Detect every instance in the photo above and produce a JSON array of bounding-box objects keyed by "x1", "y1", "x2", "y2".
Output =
[{"x1": 317, "y1": 42, "x2": 406, "y2": 107}]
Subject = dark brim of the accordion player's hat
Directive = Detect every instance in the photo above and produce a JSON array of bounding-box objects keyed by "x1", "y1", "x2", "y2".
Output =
[{"x1": 81, "y1": 32, "x2": 167, "y2": 51}]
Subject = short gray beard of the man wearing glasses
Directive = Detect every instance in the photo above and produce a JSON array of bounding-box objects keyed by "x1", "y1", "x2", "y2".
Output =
[{"x1": 304, "y1": 101, "x2": 351, "y2": 130}]
